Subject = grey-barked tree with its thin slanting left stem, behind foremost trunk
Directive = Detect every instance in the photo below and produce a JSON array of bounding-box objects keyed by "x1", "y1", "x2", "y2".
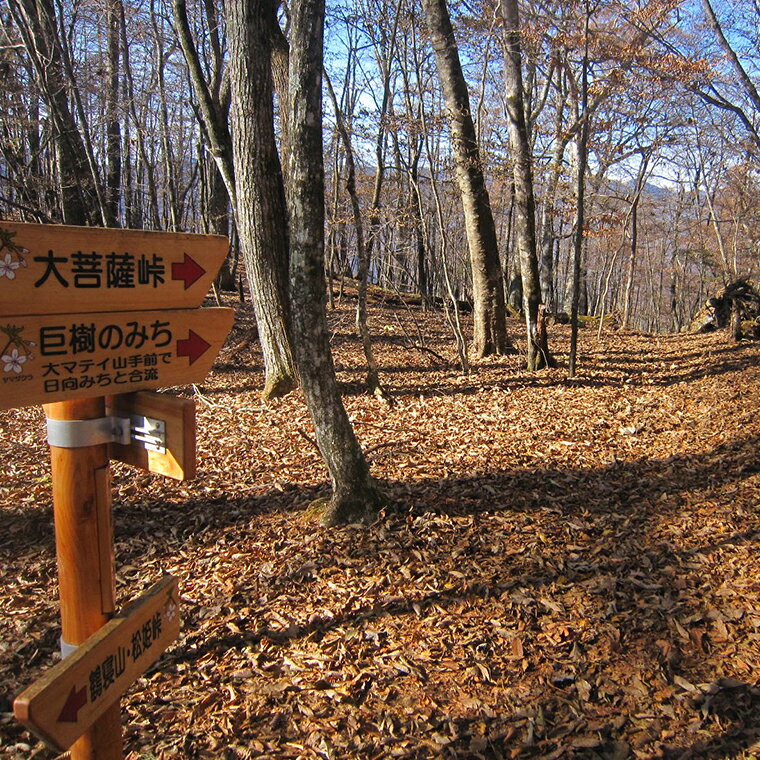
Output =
[{"x1": 173, "y1": 0, "x2": 297, "y2": 400}]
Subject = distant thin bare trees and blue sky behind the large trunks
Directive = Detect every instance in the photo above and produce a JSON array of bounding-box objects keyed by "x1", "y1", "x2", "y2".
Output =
[{"x1": 0, "y1": 0, "x2": 760, "y2": 332}]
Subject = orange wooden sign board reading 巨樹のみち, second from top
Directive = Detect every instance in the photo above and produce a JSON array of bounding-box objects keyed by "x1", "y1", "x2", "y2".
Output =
[{"x1": 0, "y1": 308, "x2": 234, "y2": 409}]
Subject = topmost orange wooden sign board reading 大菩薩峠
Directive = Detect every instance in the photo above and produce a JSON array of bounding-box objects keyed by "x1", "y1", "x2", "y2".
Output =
[{"x1": 0, "y1": 220, "x2": 228, "y2": 316}]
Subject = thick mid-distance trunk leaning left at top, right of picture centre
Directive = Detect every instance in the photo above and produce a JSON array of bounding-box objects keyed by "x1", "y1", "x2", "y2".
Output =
[{"x1": 422, "y1": 0, "x2": 513, "y2": 356}]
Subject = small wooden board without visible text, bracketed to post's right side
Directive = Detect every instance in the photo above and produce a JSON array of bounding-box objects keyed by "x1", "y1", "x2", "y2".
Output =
[{"x1": 106, "y1": 391, "x2": 195, "y2": 480}]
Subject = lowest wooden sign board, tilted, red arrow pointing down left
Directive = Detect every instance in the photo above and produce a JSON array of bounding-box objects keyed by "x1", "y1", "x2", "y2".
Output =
[{"x1": 13, "y1": 575, "x2": 180, "y2": 752}]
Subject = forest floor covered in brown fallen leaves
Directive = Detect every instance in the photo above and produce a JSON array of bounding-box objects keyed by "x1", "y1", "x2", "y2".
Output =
[{"x1": 0, "y1": 288, "x2": 760, "y2": 760}]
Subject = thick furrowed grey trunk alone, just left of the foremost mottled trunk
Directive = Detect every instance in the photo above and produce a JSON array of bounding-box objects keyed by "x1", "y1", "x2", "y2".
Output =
[{"x1": 226, "y1": 0, "x2": 296, "y2": 400}]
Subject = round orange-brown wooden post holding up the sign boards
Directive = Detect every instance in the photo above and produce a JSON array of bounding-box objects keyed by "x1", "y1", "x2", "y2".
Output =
[{"x1": 45, "y1": 398, "x2": 123, "y2": 760}]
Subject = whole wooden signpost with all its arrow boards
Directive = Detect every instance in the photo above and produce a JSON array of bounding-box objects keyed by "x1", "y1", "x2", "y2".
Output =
[{"x1": 0, "y1": 221, "x2": 234, "y2": 760}]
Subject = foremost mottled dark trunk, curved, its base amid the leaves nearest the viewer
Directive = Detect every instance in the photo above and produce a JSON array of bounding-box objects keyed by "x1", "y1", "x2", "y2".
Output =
[{"x1": 288, "y1": 0, "x2": 381, "y2": 525}]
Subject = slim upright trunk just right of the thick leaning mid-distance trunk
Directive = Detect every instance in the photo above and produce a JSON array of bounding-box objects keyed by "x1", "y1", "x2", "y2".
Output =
[{"x1": 501, "y1": 0, "x2": 555, "y2": 370}]
